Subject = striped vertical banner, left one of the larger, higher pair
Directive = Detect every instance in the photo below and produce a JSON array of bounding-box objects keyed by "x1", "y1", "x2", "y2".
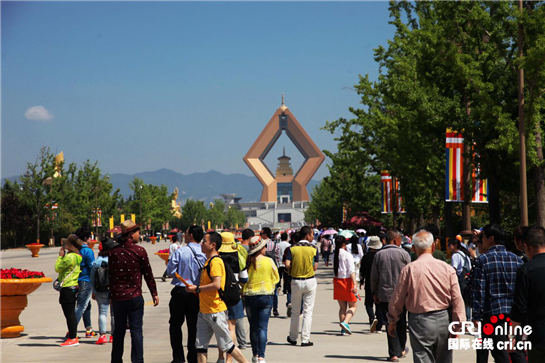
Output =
[{"x1": 445, "y1": 128, "x2": 464, "y2": 202}]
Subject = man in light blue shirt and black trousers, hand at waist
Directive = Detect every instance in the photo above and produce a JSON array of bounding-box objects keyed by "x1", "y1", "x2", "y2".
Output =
[{"x1": 167, "y1": 226, "x2": 206, "y2": 363}]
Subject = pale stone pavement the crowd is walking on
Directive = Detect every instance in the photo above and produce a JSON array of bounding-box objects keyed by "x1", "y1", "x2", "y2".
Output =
[{"x1": 0, "y1": 242, "x2": 475, "y2": 363}]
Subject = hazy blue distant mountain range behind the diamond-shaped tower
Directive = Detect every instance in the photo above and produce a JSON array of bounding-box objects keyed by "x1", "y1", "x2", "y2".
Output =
[{"x1": 2, "y1": 169, "x2": 320, "y2": 204}]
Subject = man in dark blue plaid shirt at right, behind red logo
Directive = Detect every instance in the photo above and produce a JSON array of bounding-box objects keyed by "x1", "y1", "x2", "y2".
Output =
[{"x1": 472, "y1": 224, "x2": 526, "y2": 363}]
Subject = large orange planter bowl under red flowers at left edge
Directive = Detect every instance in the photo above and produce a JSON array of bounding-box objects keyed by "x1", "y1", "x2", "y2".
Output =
[{"x1": 0, "y1": 278, "x2": 53, "y2": 338}]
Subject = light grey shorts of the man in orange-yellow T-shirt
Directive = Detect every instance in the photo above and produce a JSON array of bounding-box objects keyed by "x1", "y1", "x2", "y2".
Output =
[{"x1": 195, "y1": 311, "x2": 235, "y2": 353}]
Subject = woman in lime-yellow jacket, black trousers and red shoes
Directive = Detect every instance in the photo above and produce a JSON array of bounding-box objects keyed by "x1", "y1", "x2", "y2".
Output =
[{"x1": 55, "y1": 234, "x2": 83, "y2": 347}]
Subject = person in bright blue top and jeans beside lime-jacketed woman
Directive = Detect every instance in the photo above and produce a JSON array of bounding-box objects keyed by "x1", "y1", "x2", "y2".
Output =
[{"x1": 76, "y1": 227, "x2": 97, "y2": 338}]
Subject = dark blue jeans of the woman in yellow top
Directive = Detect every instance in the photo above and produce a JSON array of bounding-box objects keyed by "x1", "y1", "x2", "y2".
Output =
[{"x1": 246, "y1": 295, "x2": 273, "y2": 358}]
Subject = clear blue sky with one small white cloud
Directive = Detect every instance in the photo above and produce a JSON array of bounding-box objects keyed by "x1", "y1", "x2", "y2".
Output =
[{"x1": 1, "y1": 2, "x2": 394, "y2": 179}]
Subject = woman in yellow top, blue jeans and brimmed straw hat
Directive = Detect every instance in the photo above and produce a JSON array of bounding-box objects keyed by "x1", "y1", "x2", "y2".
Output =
[{"x1": 243, "y1": 236, "x2": 280, "y2": 363}]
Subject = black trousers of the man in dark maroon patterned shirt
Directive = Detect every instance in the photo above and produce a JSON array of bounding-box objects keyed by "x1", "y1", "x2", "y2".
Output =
[{"x1": 112, "y1": 296, "x2": 144, "y2": 363}]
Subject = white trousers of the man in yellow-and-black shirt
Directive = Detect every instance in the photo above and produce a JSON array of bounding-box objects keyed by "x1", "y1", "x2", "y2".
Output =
[{"x1": 290, "y1": 278, "x2": 317, "y2": 343}]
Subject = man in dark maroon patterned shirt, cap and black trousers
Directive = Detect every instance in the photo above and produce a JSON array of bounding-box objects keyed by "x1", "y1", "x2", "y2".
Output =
[{"x1": 108, "y1": 219, "x2": 159, "y2": 363}]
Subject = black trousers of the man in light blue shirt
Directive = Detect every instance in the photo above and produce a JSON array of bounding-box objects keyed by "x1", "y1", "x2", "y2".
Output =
[{"x1": 168, "y1": 286, "x2": 199, "y2": 363}]
